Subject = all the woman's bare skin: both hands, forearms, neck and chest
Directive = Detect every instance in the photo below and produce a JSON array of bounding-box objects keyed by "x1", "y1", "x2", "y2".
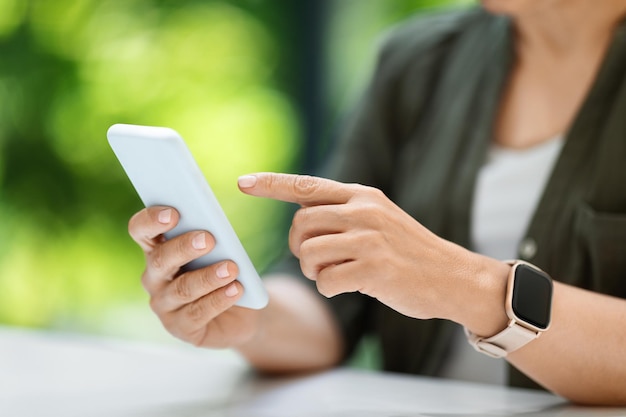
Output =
[{"x1": 129, "y1": 0, "x2": 626, "y2": 405}]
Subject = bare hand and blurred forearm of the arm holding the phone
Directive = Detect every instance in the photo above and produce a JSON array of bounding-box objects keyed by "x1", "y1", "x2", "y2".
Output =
[{"x1": 128, "y1": 206, "x2": 341, "y2": 372}]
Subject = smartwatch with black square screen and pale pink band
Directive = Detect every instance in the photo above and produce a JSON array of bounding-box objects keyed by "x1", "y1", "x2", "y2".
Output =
[{"x1": 465, "y1": 261, "x2": 553, "y2": 358}]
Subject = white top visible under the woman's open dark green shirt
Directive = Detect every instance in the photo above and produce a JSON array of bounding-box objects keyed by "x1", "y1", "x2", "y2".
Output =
[{"x1": 440, "y1": 136, "x2": 564, "y2": 384}]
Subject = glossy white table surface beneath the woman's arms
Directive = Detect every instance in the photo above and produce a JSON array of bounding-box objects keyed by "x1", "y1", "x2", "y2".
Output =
[{"x1": 0, "y1": 327, "x2": 626, "y2": 417}]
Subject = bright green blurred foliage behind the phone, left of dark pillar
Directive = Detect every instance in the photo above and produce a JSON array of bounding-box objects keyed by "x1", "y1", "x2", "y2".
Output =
[{"x1": 0, "y1": 0, "x2": 299, "y2": 332}]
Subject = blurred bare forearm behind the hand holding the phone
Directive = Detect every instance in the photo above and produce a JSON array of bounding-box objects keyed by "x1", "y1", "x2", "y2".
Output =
[{"x1": 238, "y1": 276, "x2": 343, "y2": 373}]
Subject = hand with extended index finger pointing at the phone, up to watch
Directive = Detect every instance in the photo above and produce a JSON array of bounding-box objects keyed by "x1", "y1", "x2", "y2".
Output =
[{"x1": 239, "y1": 173, "x2": 508, "y2": 331}]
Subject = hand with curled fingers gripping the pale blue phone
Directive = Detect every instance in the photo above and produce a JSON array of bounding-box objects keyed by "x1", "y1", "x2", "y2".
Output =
[{"x1": 128, "y1": 207, "x2": 260, "y2": 347}]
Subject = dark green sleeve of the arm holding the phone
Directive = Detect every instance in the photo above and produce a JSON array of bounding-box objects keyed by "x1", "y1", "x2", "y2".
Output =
[{"x1": 268, "y1": 8, "x2": 478, "y2": 359}]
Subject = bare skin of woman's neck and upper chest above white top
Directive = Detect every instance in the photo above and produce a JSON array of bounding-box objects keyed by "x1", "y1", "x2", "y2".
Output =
[{"x1": 482, "y1": 0, "x2": 626, "y2": 149}]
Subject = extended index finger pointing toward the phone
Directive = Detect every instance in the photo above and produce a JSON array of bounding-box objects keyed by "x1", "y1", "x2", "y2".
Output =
[{"x1": 238, "y1": 172, "x2": 355, "y2": 206}]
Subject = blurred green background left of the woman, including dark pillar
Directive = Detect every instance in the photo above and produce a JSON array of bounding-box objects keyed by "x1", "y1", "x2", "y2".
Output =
[{"x1": 0, "y1": 0, "x2": 469, "y2": 339}]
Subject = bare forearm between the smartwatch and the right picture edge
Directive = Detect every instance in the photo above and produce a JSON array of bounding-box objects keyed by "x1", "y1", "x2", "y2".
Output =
[{"x1": 508, "y1": 282, "x2": 626, "y2": 405}]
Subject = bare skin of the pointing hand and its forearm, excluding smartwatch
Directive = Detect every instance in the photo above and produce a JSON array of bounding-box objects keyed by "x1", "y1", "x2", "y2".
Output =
[{"x1": 240, "y1": 173, "x2": 626, "y2": 405}]
